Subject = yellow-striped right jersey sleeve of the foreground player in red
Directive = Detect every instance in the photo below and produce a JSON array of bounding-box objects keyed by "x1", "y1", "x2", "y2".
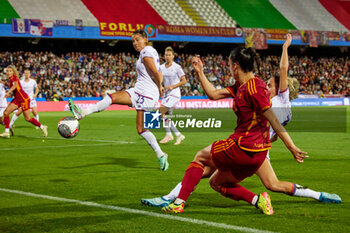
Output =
[{"x1": 248, "y1": 80, "x2": 272, "y2": 111}]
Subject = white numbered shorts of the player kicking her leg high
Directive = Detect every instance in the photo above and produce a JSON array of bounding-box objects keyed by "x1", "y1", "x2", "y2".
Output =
[{"x1": 126, "y1": 88, "x2": 158, "y2": 111}]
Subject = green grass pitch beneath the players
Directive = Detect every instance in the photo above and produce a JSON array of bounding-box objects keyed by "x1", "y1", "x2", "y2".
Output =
[{"x1": 0, "y1": 107, "x2": 350, "y2": 233}]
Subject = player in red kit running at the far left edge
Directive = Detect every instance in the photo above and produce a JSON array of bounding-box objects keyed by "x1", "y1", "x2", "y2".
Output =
[{"x1": 0, "y1": 66, "x2": 47, "y2": 138}]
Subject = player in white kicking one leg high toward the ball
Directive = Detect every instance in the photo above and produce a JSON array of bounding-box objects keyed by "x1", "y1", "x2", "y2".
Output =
[{"x1": 69, "y1": 29, "x2": 169, "y2": 171}]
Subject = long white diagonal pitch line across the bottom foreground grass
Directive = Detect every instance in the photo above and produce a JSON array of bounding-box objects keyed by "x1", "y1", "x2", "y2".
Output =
[{"x1": 0, "y1": 188, "x2": 272, "y2": 233}]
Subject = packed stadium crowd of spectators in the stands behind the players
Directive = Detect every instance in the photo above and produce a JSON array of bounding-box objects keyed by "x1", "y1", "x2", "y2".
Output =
[{"x1": 0, "y1": 51, "x2": 350, "y2": 100}]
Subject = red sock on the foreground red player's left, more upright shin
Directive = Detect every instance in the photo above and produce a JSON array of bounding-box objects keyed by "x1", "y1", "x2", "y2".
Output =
[{"x1": 178, "y1": 162, "x2": 204, "y2": 201}]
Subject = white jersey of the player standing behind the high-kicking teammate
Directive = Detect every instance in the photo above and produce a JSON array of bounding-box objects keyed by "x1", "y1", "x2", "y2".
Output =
[{"x1": 160, "y1": 62, "x2": 185, "y2": 98}]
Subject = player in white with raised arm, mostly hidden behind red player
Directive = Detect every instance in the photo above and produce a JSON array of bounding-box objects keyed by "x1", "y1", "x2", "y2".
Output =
[{"x1": 141, "y1": 34, "x2": 341, "y2": 207}]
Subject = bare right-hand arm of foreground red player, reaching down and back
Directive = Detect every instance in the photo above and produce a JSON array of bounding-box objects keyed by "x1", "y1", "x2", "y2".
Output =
[{"x1": 263, "y1": 108, "x2": 309, "y2": 163}]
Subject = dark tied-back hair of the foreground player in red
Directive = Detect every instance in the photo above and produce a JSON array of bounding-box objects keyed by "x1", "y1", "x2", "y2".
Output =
[{"x1": 230, "y1": 46, "x2": 255, "y2": 72}]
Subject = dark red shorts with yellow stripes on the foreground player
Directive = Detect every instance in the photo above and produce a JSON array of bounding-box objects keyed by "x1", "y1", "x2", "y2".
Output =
[{"x1": 210, "y1": 138, "x2": 267, "y2": 183}]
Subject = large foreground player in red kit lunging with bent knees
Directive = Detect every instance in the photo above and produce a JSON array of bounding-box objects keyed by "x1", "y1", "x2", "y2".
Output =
[{"x1": 162, "y1": 47, "x2": 307, "y2": 215}]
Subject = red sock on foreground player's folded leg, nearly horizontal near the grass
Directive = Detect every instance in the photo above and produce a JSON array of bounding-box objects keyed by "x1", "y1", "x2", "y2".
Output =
[{"x1": 220, "y1": 184, "x2": 255, "y2": 204}]
